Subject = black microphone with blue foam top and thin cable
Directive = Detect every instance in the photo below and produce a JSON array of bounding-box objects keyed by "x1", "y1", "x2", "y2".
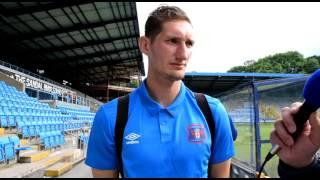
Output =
[{"x1": 258, "y1": 69, "x2": 320, "y2": 177}]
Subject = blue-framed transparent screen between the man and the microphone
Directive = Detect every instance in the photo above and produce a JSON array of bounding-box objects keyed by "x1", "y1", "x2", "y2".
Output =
[{"x1": 219, "y1": 76, "x2": 308, "y2": 177}]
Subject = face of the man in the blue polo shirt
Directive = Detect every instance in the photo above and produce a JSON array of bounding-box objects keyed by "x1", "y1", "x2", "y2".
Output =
[{"x1": 148, "y1": 20, "x2": 194, "y2": 81}]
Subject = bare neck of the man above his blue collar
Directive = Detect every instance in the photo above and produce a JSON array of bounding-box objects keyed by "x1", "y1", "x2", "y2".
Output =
[{"x1": 146, "y1": 77, "x2": 181, "y2": 107}]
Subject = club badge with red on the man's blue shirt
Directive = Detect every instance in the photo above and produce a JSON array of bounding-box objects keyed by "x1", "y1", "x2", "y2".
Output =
[{"x1": 188, "y1": 124, "x2": 206, "y2": 144}]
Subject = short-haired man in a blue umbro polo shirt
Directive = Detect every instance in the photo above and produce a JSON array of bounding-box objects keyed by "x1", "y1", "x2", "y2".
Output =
[{"x1": 86, "y1": 6, "x2": 234, "y2": 177}]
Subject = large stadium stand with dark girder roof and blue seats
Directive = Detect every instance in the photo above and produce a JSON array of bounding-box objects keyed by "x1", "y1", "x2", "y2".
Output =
[{"x1": 0, "y1": 1, "x2": 145, "y2": 177}]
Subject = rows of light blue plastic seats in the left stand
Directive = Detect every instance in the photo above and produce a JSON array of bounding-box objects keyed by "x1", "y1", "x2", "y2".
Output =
[{"x1": 0, "y1": 80, "x2": 95, "y2": 167}]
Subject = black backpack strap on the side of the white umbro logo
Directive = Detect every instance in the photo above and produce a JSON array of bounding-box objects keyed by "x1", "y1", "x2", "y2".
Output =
[{"x1": 115, "y1": 95, "x2": 129, "y2": 177}]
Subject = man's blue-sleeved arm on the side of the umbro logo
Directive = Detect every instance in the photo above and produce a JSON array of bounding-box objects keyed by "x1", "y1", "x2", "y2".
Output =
[{"x1": 85, "y1": 100, "x2": 118, "y2": 177}]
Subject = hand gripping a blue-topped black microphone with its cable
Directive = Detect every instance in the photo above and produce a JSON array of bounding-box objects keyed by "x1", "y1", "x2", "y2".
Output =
[{"x1": 260, "y1": 69, "x2": 320, "y2": 177}]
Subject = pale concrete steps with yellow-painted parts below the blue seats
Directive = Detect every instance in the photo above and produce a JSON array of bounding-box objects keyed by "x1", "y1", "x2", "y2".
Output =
[{"x1": 0, "y1": 128, "x2": 84, "y2": 178}]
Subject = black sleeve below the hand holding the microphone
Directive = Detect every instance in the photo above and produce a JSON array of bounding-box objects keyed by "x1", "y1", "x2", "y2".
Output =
[{"x1": 278, "y1": 155, "x2": 320, "y2": 179}]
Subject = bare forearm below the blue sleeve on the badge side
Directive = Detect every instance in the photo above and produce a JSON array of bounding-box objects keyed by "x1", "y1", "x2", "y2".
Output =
[{"x1": 208, "y1": 159, "x2": 231, "y2": 178}]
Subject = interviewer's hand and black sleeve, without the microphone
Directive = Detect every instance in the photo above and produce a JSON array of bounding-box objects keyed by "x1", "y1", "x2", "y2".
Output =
[{"x1": 270, "y1": 103, "x2": 320, "y2": 179}]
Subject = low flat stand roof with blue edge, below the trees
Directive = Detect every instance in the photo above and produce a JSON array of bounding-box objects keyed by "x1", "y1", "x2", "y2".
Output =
[{"x1": 183, "y1": 72, "x2": 305, "y2": 96}]
